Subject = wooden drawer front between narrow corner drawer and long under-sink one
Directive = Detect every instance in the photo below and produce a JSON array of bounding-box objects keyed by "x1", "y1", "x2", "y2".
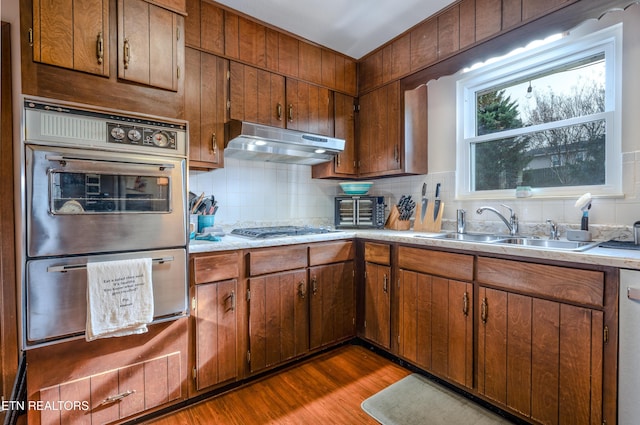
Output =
[{"x1": 398, "y1": 246, "x2": 473, "y2": 281}]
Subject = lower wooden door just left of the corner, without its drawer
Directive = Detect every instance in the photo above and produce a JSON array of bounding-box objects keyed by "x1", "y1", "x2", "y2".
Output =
[{"x1": 309, "y1": 261, "x2": 355, "y2": 349}]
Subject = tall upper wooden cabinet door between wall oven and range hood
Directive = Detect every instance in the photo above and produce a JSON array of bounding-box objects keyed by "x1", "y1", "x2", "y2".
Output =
[{"x1": 184, "y1": 48, "x2": 229, "y2": 169}]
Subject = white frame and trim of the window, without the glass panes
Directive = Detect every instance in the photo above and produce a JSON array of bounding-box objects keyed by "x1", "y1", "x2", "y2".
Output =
[{"x1": 456, "y1": 23, "x2": 624, "y2": 200}]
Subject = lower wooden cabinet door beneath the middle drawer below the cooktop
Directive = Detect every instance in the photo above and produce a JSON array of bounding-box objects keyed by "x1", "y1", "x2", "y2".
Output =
[{"x1": 249, "y1": 270, "x2": 309, "y2": 373}]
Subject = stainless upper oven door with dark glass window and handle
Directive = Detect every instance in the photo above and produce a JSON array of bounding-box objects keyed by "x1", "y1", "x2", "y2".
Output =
[{"x1": 25, "y1": 145, "x2": 187, "y2": 257}]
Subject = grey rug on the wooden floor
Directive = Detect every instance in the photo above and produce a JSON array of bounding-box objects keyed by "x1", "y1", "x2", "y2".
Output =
[{"x1": 362, "y1": 373, "x2": 511, "y2": 425}]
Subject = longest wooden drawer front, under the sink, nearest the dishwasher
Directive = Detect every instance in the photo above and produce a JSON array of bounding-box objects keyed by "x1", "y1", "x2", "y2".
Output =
[{"x1": 476, "y1": 257, "x2": 604, "y2": 307}]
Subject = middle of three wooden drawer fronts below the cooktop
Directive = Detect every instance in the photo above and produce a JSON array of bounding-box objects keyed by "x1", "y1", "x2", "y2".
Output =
[{"x1": 249, "y1": 245, "x2": 307, "y2": 276}]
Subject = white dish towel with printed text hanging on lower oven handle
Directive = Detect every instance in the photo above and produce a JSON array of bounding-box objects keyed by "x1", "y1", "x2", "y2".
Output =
[{"x1": 85, "y1": 258, "x2": 153, "y2": 341}]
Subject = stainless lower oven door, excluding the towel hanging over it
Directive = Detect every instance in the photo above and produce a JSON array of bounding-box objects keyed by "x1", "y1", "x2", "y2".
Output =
[{"x1": 23, "y1": 245, "x2": 188, "y2": 348}]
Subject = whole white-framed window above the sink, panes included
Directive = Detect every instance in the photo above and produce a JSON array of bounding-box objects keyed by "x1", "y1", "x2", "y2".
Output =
[{"x1": 456, "y1": 24, "x2": 622, "y2": 198}]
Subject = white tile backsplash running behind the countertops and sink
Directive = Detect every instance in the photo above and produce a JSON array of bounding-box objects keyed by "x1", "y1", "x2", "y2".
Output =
[{"x1": 189, "y1": 152, "x2": 640, "y2": 239}]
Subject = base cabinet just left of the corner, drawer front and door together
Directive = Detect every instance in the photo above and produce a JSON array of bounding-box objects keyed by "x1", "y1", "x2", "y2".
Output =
[{"x1": 309, "y1": 241, "x2": 356, "y2": 350}]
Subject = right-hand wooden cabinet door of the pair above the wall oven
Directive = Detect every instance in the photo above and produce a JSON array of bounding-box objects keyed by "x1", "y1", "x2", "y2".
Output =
[{"x1": 118, "y1": 0, "x2": 184, "y2": 91}]
